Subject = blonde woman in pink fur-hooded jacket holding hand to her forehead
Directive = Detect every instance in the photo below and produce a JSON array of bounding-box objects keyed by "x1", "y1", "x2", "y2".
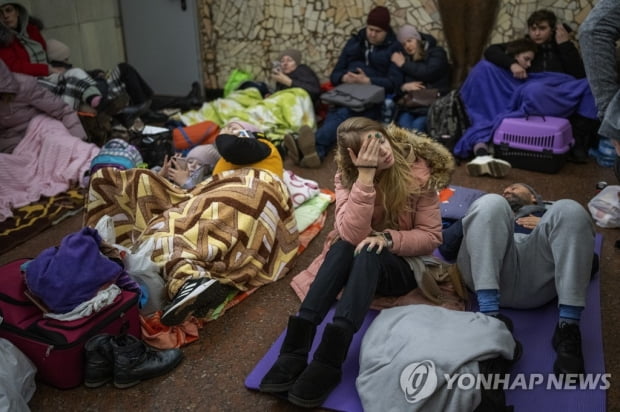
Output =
[{"x1": 260, "y1": 117, "x2": 454, "y2": 408}]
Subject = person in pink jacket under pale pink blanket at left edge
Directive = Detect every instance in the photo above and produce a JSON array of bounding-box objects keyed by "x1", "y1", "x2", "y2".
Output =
[{"x1": 0, "y1": 60, "x2": 99, "y2": 222}]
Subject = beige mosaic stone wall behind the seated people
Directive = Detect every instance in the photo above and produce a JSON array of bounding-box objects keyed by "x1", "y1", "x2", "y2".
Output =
[{"x1": 199, "y1": 0, "x2": 596, "y2": 88}]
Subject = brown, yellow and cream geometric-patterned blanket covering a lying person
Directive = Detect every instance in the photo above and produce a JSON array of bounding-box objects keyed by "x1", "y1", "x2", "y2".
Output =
[{"x1": 86, "y1": 168, "x2": 299, "y2": 298}]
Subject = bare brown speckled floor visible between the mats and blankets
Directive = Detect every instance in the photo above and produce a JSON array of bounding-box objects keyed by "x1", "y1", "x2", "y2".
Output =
[{"x1": 0, "y1": 151, "x2": 620, "y2": 411}]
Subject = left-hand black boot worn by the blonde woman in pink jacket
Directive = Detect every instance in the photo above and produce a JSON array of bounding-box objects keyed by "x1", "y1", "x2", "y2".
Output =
[{"x1": 259, "y1": 316, "x2": 316, "y2": 393}]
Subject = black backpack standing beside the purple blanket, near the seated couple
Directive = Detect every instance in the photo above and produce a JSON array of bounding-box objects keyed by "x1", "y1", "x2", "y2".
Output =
[{"x1": 426, "y1": 89, "x2": 471, "y2": 151}]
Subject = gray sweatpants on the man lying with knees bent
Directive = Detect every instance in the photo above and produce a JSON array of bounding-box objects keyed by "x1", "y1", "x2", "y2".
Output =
[{"x1": 457, "y1": 194, "x2": 594, "y2": 308}]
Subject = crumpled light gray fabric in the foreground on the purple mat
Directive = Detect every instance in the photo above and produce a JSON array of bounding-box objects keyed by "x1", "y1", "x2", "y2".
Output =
[{"x1": 356, "y1": 305, "x2": 515, "y2": 412}]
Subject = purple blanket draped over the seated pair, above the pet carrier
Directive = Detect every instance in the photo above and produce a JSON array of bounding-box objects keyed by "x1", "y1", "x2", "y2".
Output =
[{"x1": 454, "y1": 60, "x2": 597, "y2": 158}]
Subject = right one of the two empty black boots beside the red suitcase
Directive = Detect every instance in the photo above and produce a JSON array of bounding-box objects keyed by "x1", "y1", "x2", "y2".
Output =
[{"x1": 111, "y1": 335, "x2": 183, "y2": 388}]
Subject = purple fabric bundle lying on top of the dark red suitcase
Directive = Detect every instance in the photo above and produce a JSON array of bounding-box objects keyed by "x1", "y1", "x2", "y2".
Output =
[{"x1": 26, "y1": 227, "x2": 124, "y2": 313}]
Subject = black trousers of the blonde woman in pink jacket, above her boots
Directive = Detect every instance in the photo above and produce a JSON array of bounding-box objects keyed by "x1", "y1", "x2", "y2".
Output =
[{"x1": 299, "y1": 240, "x2": 417, "y2": 332}]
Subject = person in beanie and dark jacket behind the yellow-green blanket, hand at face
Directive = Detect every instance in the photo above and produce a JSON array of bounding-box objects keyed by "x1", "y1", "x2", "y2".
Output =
[{"x1": 271, "y1": 49, "x2": 321, "y2": 106}]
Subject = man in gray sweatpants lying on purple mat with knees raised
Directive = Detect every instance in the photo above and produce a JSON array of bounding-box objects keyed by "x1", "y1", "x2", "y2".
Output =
[{"x1": 439, "y1": 183, "x2": 598, "y2": 375}]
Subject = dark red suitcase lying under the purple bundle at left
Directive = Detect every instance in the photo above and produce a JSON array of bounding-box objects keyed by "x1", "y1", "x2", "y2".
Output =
[{"x1": 0, "y1": 259, "x2": 141, "y2": 389}]
